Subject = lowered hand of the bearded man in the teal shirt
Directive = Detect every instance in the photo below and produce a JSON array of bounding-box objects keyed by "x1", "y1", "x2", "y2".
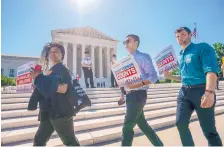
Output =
[{"x1": 201, "y1": 92, "x2": 215, "y2": 108}]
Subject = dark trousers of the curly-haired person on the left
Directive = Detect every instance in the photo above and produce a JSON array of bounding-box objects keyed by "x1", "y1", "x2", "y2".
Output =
[{"x1": 33, "y1": 117, "x2": 80, "y2": 146}]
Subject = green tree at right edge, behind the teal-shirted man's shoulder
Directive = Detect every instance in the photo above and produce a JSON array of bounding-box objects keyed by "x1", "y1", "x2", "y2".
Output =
[{"x1": 213, "y1": 42, "x2": 224, "y2": 74}]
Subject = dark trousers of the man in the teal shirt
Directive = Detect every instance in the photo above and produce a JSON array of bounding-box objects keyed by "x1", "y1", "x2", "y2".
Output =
[{"x1": 176, "y1": 85, "x2": 222, "y2": 146}]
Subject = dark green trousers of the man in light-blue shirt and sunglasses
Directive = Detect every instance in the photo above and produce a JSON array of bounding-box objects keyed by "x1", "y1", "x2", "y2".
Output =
[{"x1": 122, "y1": 90, "x2": 163, "y2": 146}]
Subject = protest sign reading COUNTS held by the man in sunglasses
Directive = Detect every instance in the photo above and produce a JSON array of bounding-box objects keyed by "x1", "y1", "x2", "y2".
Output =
[{"x1": 112, "y1": 55, "x2": 142, "y2": 90}]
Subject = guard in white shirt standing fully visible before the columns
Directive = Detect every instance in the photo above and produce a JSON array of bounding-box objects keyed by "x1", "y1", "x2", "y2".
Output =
[{"x1": 82, "y1": 51, "x2": 96, "y2": 88}]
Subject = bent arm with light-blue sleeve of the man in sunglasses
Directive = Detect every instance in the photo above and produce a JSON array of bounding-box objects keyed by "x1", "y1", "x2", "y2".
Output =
[{"x1": 127, "y1": 55, "x2": 158, "y2": 89}]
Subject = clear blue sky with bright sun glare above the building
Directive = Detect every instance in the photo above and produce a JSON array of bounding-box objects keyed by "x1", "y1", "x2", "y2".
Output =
[{"x1": 1, "y1": 0, "x2": 224, "y2": 59}]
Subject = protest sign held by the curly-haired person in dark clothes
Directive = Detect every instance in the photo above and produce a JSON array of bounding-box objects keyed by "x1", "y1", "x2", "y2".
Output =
[{"x1": 16, "y1": 61, "x2": 35, "y2": 93}]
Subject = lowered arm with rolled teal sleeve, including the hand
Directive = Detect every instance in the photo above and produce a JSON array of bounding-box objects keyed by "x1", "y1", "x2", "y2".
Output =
[{"x1": 200, "y1": 43, "x2": 218, "y2": 108}]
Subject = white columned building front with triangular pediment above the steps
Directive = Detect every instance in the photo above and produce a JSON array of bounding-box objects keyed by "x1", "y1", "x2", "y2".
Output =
[{"x1": 51, "y1": 27, "x2": 118, "y2": 87}]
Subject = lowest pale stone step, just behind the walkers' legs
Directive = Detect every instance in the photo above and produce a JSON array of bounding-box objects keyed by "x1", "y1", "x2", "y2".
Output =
[{"x1": 2, "y1": 106, "x2": 224, "y2": 146}]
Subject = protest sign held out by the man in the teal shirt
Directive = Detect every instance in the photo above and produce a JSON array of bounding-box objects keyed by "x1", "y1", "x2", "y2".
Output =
[{"x1": 154, "y1": 45, "x2": 178, "y2": 75}]
